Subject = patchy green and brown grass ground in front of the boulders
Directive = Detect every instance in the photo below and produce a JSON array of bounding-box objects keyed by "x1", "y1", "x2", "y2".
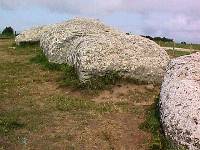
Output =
[{"x1": 0, "y1": 39, "x2": 188, "y2": 150}]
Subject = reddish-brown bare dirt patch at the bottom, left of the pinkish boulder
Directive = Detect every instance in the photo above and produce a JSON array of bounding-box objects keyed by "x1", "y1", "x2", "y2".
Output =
[{"x1": 74, "y1": 113, "x2": 150, "y2": 149}]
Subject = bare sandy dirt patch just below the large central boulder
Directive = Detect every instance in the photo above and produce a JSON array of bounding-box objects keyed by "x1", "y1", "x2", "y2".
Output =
[{"x1": 93, "y1": 83, "x2": 159, "y2": 105}]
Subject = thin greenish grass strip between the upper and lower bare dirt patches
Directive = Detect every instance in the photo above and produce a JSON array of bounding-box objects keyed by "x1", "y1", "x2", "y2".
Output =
[{"x1": 50, "y1": 96, "x2": 147, "y2": 115}]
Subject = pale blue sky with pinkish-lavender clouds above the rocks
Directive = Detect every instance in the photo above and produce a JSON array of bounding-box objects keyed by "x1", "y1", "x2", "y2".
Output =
[{"x1": 0, "y1": 0, "x2": 200, "y2": 43}]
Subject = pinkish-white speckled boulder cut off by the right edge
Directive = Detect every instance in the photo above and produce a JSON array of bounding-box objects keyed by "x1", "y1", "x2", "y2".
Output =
[{"x1": 160, "y1": 53, "x2": 200, "y2": 150}]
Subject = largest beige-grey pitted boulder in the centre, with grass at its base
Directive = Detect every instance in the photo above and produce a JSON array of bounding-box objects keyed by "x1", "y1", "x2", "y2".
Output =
[{"x1": 40, "y1": 18, "x2": 169, "y2": 83}]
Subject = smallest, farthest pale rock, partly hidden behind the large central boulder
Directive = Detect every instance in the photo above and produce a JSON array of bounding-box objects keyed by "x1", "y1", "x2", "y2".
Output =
[{"x1": 15, "y1": 25, "x2": 54, "y2": 45}]
